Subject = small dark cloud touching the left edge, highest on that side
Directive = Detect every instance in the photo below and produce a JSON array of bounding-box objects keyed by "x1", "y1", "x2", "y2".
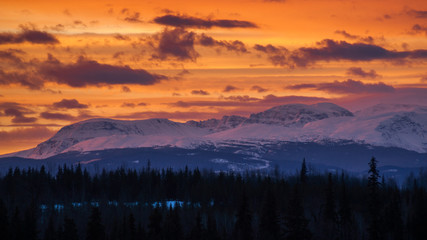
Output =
[{"x1": 0, "y1": 26, "x2": 59, "y2": 45}]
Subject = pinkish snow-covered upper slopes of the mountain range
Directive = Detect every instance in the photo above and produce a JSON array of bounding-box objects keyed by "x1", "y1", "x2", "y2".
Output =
[{"x1": 3, "y1": 103, "x2": 427, "y2": 159}]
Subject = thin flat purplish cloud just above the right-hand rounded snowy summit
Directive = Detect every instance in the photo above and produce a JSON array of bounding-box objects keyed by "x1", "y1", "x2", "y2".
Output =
[{"x1": 287, "y1": 79, "x2": 395, "y2": 94}]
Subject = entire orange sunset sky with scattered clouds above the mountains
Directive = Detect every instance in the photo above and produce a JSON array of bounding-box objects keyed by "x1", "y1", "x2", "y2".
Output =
[{"x1": 0, "y1": 0, "x2": 427, "y2": 154}]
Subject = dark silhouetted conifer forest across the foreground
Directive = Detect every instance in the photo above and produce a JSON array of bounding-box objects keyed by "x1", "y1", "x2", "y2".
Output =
[{"x1": 0, "y1": 158, "x2": 427, "y2": 240}]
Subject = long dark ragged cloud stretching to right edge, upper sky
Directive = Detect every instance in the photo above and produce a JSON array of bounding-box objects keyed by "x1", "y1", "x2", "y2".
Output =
[{"x1": 254, "y1": 39, "x2": 427, "y2": 68}]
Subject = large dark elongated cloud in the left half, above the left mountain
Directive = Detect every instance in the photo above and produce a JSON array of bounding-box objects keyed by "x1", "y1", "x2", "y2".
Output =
[{"x1": 39, "y1": 56, "x2": 167, "y2": 87}]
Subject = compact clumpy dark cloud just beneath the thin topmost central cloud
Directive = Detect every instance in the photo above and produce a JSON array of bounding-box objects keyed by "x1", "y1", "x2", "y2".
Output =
[{"x1": 152, "y1": 28, "x2": 199, "y2": 61}]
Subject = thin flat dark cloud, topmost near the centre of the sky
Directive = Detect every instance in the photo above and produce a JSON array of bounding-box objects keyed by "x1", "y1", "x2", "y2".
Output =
[{"x1": 153, "y1": 14, "x2": 258, "y2": 29}]
